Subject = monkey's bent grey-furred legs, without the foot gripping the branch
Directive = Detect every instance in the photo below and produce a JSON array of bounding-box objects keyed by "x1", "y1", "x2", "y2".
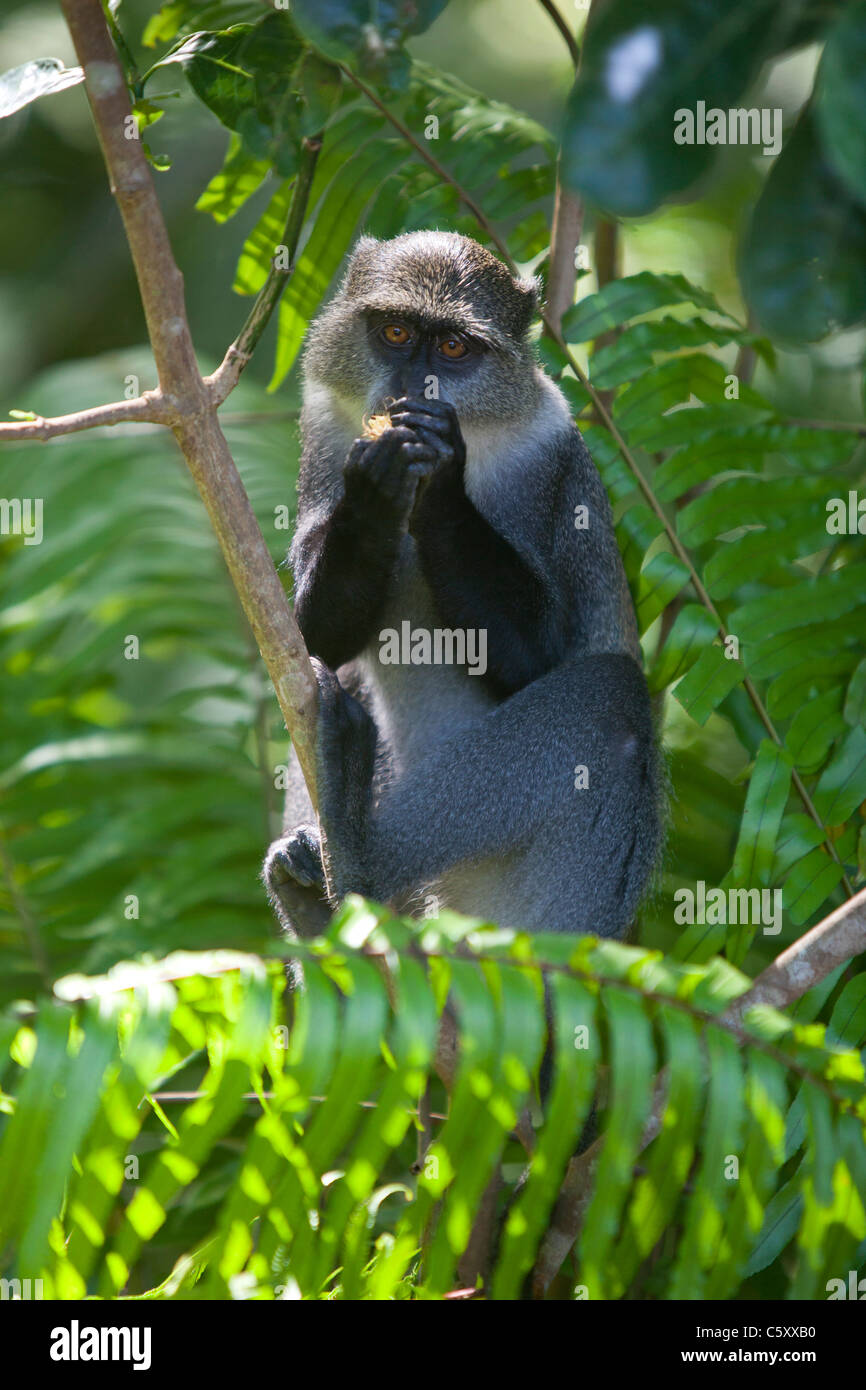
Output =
[{"x1": 317, "y1": 655, "x2": 660, "y2": 935}]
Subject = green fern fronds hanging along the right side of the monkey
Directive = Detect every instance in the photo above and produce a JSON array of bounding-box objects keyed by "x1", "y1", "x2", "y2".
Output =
[{"x1": 563, "y1": 272, "x2": 866, "y2": 960}]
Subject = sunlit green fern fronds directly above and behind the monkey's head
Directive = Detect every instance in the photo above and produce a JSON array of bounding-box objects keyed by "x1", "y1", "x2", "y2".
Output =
[{"x1": 209, "y1": 64, "x2": 555, "y2": 388}]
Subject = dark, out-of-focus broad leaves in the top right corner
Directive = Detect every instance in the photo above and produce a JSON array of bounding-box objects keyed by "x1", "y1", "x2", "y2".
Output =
[{"x1": 563, "y1": 0, "x2": 866, "y2": 342}]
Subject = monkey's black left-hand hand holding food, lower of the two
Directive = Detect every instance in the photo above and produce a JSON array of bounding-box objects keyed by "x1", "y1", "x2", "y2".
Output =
[{"x1": 343, "y1": 425, "x2": 432, "y2": 521}]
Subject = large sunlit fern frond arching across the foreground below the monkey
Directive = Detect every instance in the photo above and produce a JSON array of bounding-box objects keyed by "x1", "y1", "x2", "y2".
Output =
[{"x1": 0, "y1": 899, "x2": 866, "y2": 1298}]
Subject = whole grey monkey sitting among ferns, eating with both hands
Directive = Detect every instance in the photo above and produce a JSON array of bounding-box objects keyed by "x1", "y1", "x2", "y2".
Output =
[{"x1": 263, "y1": 231, "x2": 662, "y2": 938}]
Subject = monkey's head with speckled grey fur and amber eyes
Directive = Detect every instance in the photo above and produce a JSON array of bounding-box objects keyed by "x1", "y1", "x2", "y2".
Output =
[{"x1": 304, "y1": 232, "x2": 539, "y2": 424}]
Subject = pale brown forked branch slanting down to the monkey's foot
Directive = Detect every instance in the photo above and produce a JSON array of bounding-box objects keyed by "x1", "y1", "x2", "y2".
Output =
[{"x1": 46, "y1": 0, "x2": 317, "y2": 805}]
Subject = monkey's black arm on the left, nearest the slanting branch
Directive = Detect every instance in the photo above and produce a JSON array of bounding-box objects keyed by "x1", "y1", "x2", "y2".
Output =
[{"x1": 291, "y1": 430, "x2": 427, "y2": 670}]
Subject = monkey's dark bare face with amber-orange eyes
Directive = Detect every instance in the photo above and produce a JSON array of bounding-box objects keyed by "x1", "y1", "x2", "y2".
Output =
[{"x1": 367, "y1": 313, "x2": 488, "y2": 400}]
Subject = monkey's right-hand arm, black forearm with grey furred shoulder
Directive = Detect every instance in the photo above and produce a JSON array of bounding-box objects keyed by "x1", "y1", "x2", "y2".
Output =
[{"x1": 403, "y1": 402, "x2": 641, "y2": 683}]
